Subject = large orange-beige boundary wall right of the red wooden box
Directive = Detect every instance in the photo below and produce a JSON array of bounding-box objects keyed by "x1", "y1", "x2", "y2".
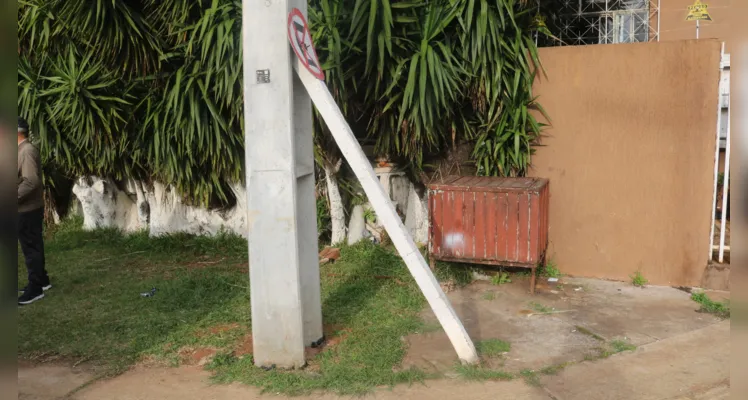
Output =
[{"x1": 532, "y1": 40, "x2": 720, "y2": 286}]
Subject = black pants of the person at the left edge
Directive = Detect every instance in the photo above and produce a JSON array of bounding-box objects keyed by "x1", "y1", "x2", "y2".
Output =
[{"x1": 18, "y1": 208, "x2": 49, "y2": 293}]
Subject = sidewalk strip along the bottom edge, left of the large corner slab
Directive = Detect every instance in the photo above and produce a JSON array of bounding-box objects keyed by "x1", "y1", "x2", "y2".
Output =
[{"x1": 18, "y1": 366, "x2": 549, "y2": 400}]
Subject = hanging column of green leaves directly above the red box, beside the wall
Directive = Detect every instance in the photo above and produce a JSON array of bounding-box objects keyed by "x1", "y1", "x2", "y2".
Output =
[{"x1": 461, "y1": 0, "x2": 547, "y2": 176}]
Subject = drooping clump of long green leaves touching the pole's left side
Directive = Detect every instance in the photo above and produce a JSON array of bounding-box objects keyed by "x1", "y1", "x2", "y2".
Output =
[{"x1": 140, "y1": 0, "x2": 244, "y2": 204}]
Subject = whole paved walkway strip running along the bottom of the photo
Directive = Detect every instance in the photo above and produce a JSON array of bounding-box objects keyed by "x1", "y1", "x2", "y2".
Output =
[{"x1": 18, "y1": 321, "x2": 730, "y2": 400}]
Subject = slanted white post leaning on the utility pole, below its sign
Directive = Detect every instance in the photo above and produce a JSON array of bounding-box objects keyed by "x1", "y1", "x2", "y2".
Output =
[{"x1": 293, "y1": 59, "x2": 479, "y2": 364}]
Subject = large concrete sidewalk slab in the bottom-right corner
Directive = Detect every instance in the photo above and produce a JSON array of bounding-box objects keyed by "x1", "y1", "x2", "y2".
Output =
[{"x1": 541, "y1": 321, "x2": 730, "y2": 400}]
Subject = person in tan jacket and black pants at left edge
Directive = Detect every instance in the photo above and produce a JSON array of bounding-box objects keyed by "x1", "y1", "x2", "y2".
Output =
[{"x1": 18, "y1": 117, "x2": 52, "y2": 305}]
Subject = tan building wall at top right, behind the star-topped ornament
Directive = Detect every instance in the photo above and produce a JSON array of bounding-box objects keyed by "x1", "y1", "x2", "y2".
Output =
[{"x1": 650, "y1": 0, "x2": 732, "y2": 52}]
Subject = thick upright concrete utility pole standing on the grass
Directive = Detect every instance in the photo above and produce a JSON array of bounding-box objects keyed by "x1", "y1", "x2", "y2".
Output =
[{"x1": 242, "y1": 0, "x2": 323, "y2": 368}]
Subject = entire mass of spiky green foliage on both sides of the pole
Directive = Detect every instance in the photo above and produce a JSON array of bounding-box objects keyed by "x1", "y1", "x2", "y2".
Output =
[{"x1": 18, "y1": 0, "x2": 543, "y2": 206}]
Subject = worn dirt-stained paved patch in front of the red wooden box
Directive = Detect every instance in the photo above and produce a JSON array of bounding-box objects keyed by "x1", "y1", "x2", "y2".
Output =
[{"x1": 403, "y1": 279, "x2": 720, "y2": 373}]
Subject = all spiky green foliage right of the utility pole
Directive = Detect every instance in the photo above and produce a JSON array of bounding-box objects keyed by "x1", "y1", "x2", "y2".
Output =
[{"x1": 322, "y1": 0, "x2": 548, "y2": 176}]
